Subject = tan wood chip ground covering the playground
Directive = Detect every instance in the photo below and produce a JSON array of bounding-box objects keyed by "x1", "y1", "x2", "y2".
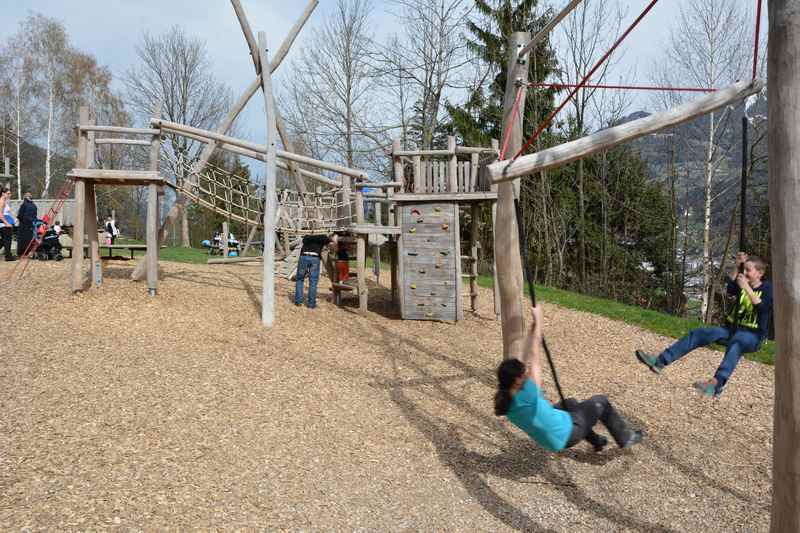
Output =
[{"x1": 0, "y1": 261, "x2": 773, "y2": 532}]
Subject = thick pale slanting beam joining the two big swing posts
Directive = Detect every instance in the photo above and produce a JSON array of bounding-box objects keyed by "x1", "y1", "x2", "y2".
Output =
[{"x1": 489, "y1": 79, "x2": 764, "y2": 183}]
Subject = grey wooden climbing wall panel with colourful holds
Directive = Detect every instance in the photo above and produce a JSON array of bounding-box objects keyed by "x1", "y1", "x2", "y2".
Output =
[{"x1": 398, "y1": 202, "x2": 463, "y2": 321}]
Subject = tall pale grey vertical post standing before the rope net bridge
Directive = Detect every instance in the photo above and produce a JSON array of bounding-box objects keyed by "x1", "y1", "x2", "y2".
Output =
[{"x1": 258, "y1": 31, "x2": 278, "y2": 327}]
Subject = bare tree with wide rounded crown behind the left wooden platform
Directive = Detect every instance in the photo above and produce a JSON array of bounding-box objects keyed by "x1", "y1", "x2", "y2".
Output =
[{"x1": 124, "y1": 26, "x2": 232, "y2": 247}]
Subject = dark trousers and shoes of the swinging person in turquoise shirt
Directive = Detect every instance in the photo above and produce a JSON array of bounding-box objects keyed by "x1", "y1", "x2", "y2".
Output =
[{"x1": 560, "y1": 394, "x2": 632, "y2": 448}]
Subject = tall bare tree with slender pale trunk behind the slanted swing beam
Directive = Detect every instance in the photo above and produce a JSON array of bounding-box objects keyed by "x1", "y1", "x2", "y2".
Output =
[{"x1": 654, "y1": 0, "x2": 752, "y2": 320}]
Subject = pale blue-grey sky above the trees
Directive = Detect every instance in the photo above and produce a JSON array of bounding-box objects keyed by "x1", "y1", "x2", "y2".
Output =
[{"x1": 0, "y1": 0, "x2": 768, "y2": 179}]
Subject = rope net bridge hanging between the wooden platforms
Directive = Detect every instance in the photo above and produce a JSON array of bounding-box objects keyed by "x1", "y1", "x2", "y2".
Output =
[{"x1": 161, "y1": 151, "x2": 355, "y2": 234}]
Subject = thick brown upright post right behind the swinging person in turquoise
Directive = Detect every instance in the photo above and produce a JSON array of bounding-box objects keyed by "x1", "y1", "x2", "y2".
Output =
[{"x1": 494, "y1": 32, "x2": 530, "y2": 360}]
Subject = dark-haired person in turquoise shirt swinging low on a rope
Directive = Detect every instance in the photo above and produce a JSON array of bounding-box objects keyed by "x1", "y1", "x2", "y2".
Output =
[{"x1": 494, "y1": 305, "x2": 642, "y2": 452}]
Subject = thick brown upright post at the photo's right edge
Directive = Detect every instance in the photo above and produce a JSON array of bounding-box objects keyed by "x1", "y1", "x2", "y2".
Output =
[{"x1": 767, "y1": 0, "x2": 800, "y2": 533}]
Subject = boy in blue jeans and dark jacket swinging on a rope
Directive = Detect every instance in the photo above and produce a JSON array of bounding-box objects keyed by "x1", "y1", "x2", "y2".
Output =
[{"x1": 636, "y1": 252, "x2": 772, "y2": 398}]
